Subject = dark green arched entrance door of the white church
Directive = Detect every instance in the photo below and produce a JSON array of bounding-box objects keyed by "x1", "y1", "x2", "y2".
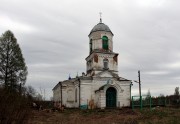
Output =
[{"x1": 106, "y1": 87, "x2": 117, "y2": 108}]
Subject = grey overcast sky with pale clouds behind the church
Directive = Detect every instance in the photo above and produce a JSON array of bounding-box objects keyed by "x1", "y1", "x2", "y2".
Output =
[{"x1": 0, "y1": 0, "x2": 180, "y2": 99}]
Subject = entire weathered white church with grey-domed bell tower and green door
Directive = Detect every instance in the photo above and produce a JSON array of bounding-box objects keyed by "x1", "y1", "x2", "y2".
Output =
[{"x1": 52, "y1": 18, "x2": 131, "y2": 109}]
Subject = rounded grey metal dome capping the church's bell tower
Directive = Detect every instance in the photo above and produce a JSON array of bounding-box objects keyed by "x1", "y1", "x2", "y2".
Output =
[{"x1": 89, "y1": 22, "x2": 113, "y2": 35}]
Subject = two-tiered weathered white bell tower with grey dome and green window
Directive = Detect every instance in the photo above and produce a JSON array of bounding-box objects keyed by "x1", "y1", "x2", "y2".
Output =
[{"x1": 86, "y1": 17, "x2": 118, "y2": 76}]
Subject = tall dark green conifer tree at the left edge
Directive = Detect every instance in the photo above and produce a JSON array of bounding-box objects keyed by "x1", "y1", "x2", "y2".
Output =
[{"x1": 0, "y1": 30, "x2": 28, "y2": 89}]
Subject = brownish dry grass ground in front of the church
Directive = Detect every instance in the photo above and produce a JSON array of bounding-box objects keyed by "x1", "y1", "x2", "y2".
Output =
[{"x1": 28, "y1": 107, "x2": 180, "y2": 124}]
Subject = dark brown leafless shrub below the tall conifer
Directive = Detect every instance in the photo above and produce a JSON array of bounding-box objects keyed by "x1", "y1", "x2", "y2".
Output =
[{"x1": 0, "y1": 89, "x2": 30, "y2": 124}]
